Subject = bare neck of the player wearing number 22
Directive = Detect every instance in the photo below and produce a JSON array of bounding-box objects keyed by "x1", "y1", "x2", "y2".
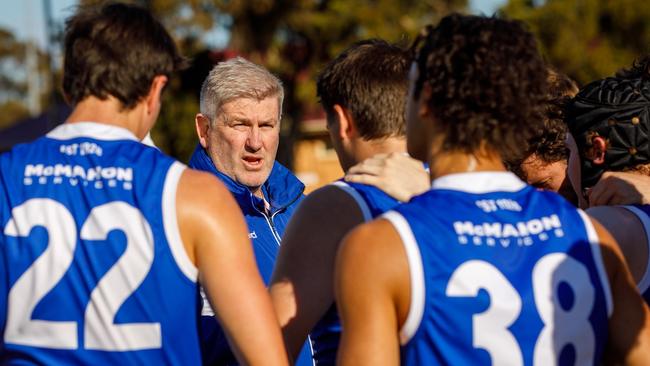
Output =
[{"x1": 65, "y1": 96, "x2": 147, "y2": 139}]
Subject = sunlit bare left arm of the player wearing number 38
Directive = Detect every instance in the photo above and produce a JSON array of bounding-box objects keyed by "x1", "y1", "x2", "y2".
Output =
[{"x1": 335, "y1": 220, "x2": 410, "y2": 365}]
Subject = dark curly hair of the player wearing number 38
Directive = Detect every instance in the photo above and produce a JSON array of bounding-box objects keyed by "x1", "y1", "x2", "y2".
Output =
[{"x1": 413, "y1": 14, "x2": 547, "y2": 157}]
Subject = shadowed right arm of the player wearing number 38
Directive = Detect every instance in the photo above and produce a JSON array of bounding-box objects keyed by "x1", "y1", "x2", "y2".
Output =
[{"x1": 593, "y1": 220, "x2": 650, "y2": 365}]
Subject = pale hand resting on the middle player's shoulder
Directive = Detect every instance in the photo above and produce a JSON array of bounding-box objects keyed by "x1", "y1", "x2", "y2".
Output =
[{"x1": 345, "y1": 153, "x2": 431, "y2": 202}]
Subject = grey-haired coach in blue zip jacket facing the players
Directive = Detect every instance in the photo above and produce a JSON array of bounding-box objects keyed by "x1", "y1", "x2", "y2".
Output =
[{"x1": 189, "y1": 57, "x2": 313, "y2": 366}]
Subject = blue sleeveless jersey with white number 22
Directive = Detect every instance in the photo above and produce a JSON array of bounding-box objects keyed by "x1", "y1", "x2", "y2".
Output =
[{"x1": 0, "y1": 123, "x2": 201, "y2": 365}]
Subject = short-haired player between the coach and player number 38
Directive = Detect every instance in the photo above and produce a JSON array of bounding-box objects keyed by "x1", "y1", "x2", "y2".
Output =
[{"x1": 270, "y1": 40, "x2": 426, "y2": 365}]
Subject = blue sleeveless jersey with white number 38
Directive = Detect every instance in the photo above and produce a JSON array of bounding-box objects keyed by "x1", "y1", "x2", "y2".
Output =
[{"x1": 383, "y1": 172, "x2": 612, "y2": 365}]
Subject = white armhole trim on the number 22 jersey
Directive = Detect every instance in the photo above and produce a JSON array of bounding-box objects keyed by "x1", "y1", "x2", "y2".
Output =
[{"x1": 162, "y1": 162, "x2": 199, "y2": 282}]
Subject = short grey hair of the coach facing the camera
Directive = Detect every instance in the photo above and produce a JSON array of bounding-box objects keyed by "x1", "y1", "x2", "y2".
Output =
[{"x1": 200, "y1": 57, "x2": 284, "y2": 121}]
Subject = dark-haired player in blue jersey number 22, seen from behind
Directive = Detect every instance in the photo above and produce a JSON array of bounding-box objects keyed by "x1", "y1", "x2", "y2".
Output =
[{"x1": 0, "y1": 4, "x2": 287, "y2": 365}]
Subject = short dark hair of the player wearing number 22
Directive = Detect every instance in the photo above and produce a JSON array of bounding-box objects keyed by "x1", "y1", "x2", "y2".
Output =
[{"x1": 63, "y1": 3, "x2": 185, "y2": 110}]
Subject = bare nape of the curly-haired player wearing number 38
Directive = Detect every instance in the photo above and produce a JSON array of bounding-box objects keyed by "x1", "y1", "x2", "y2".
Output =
[{"x1": 429, "y1": 151, "x2": 506, "y2": 180}]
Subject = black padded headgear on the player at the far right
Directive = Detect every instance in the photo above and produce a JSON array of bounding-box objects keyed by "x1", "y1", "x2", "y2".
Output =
[{"x1": 566, "y1": 78, "x2": 650, "y2": 187}]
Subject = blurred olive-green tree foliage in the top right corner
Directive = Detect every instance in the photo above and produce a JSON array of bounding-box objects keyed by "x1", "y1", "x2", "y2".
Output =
[{"x1": 501, "y1": 0, "x2": 650, "y2": 85}]
